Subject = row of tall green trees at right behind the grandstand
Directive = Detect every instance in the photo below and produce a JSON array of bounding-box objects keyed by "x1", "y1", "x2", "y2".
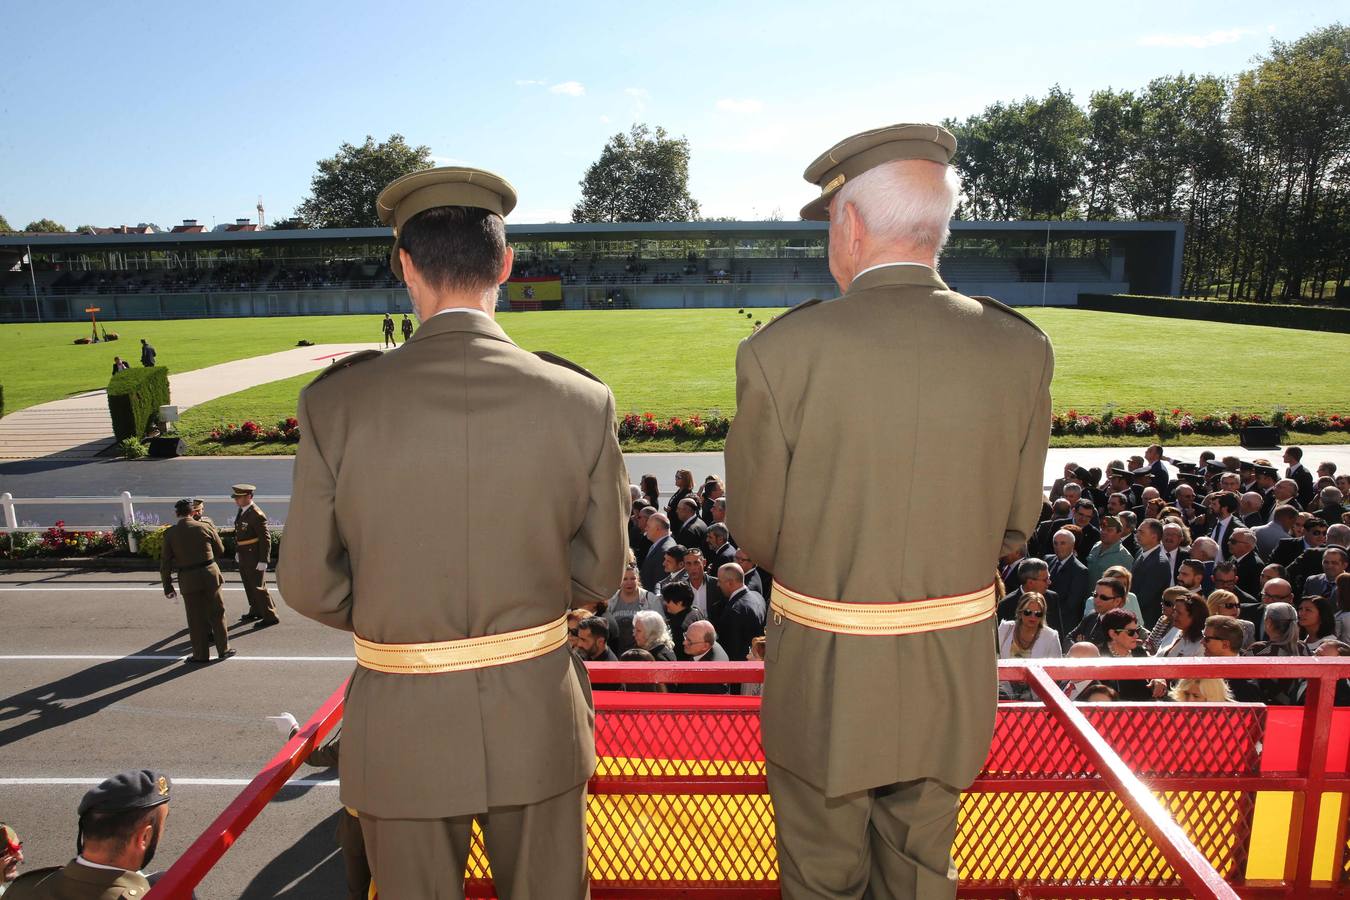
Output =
[{"x1": 944, "y1": 24, "x2": 1350, "y2": 301}]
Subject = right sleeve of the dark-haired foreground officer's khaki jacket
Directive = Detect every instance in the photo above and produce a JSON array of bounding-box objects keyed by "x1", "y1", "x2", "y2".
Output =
[{"x1": 568, "y1": 394, "x2": 629, "y2": 609}]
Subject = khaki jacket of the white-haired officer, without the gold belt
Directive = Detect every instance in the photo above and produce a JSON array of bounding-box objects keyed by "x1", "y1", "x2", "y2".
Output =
[{"x1": 726, "y1": 266, "x2": 1054, "y2": 796}]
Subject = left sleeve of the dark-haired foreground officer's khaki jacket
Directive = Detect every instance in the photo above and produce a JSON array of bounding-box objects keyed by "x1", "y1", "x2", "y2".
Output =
[{"x1": 277, "y1": 394, "x2": 352, "y2": 631}]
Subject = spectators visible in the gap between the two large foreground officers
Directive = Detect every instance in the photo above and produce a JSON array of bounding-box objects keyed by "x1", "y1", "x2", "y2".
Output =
[{"x1": 567, "y1": 470, "x2": 774, "y2": 694}]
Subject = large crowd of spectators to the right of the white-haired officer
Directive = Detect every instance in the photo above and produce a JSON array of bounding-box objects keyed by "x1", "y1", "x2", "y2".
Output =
[{"x1": 996, "y1": 445, "x2": 1350, "y2": 704}]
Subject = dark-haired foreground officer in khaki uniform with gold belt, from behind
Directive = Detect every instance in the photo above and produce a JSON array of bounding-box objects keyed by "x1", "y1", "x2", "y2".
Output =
[{"x1": 278, "y1": 167, "x2": 629, "y2": 900}]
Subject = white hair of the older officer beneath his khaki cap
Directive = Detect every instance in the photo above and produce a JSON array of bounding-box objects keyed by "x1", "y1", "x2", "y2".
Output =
[{"x1": 834, "y1": 159, "x2": 961, "y2": 256}]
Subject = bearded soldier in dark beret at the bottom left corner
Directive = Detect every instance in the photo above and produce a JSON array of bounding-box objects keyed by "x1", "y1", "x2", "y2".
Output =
[{"x1": 5, "y1": 769, "x2": 170, "y2": 900}]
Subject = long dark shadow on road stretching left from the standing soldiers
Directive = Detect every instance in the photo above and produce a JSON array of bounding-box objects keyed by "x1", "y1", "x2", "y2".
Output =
[{"x1": 0, "y1": 629, "x2": 196, "y2": 748}]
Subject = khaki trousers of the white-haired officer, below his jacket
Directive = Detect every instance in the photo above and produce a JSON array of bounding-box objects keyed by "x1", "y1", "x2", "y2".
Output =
[{"x1": 767, "y1": 762, "x2": 960, "y2": 900}]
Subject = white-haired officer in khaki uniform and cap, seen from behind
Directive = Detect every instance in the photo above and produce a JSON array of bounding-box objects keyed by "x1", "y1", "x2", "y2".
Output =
[{"x1": 726, "y1": 125, "x2": 1054, "y2": 900}]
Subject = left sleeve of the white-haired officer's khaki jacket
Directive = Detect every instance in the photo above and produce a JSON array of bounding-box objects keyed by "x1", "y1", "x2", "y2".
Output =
[{"x1": 725, "y1": 340, "x2": 791, "y2": 572}]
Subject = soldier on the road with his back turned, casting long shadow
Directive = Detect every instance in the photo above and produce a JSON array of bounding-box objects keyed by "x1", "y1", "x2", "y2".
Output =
[{"x1": 159, "y1": 501, "x2": 235, "y2": 664}]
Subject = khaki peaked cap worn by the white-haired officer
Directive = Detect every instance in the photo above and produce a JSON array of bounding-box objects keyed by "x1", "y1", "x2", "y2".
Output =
[{"x1": 802, "y1": 124, "x2": 956, "y2": 221}]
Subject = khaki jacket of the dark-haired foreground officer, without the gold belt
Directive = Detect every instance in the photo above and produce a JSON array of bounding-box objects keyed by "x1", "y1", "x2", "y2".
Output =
[{"x1": 278, "y1": 312, "x2": 629, "y2": 819}]
